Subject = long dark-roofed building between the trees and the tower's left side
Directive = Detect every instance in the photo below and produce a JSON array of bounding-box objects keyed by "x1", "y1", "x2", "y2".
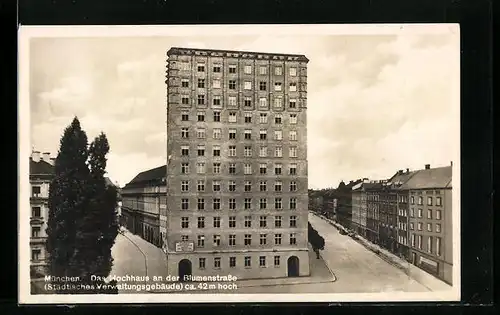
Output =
[{"x1": 120, "y1": 165, "x2": 167, "y2": 247}]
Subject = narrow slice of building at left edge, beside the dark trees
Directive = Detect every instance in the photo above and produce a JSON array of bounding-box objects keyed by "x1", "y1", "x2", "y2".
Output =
[{"x1": 29, "y1": 151, "x2": 54, "y2": 278}]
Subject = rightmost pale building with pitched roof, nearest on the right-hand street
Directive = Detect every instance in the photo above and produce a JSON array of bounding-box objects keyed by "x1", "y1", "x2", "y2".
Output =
[{"x1": 401, "y1": 164, "x2": 453, "y2": 284}]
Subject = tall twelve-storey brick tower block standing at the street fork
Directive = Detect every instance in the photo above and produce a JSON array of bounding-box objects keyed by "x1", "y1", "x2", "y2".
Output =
[{"x1": 164, "y1": 48, "x2": 309, "y2": 279}]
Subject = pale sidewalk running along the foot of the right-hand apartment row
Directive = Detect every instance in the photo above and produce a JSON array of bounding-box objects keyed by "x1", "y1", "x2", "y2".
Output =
[{"x1": 314, "y1": 214, "x2": 452, "y2": 291}]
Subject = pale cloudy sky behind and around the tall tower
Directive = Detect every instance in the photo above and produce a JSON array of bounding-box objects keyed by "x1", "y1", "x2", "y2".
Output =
[{"x1": 29, "y1": 25, "x2": 459, "y2": 189}]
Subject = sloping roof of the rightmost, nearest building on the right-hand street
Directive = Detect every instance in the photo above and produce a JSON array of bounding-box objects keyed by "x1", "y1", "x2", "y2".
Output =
[{"x1": 400, "y1": 166, "x2": 452, "y2": 189}]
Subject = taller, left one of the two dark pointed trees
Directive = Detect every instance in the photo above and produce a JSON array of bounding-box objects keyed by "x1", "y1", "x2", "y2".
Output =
[{"x1": 47, "y1": 117, "x2": 89, "y2": 293}]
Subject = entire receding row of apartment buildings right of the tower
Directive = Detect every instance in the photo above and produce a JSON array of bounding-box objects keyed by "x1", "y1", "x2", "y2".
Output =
[{"x1": 331, "y1": 164, "x2": 453, "y2": 284}]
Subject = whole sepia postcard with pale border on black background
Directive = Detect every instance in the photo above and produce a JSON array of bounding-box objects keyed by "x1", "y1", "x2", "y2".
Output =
[{"x1": 18, "y1": 24, "x2": 460, "y2": 304}]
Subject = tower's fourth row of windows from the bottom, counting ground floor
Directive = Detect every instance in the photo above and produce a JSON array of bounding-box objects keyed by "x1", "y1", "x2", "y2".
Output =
[{"x1": 181, "y1": 197, "x2": 297, "y2": 210}]
